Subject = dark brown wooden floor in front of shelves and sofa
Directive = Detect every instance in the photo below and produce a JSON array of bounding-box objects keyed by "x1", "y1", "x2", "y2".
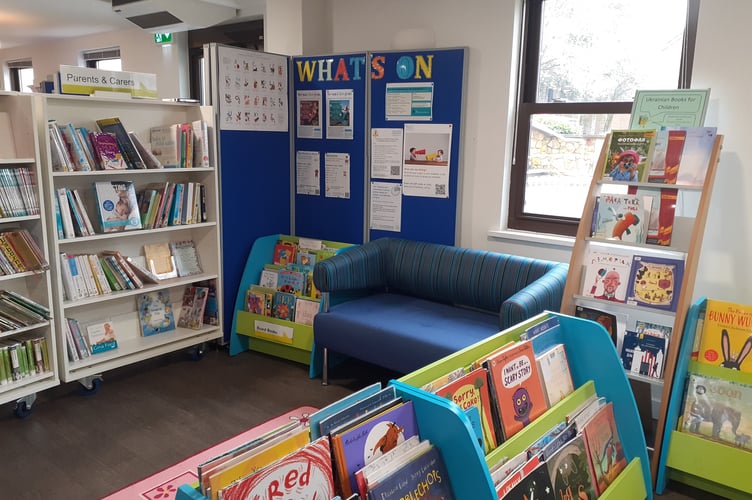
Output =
[{"x1": 0, "y1": 348, "x2": 724, "y2": 500}]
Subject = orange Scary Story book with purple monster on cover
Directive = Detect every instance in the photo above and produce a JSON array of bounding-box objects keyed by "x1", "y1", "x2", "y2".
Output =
[{"x1": 485, "y1": 340, "x2": 548, "y2": 439}]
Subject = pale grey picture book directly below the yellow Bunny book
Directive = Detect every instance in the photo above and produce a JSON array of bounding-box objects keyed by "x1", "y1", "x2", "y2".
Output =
[{"x1": 679, "y1": 373, "x2": 752, "y2": 451}]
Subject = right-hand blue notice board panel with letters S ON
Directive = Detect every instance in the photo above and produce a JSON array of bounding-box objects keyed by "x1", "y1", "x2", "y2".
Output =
[{"x1": 369, "y1": 48, "x2": 467, "y2": 245}]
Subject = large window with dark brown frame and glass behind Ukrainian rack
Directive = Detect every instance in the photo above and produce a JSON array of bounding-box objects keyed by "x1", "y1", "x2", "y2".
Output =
[{"x1": 507, "y1": 0, "x2": 699, "y2": 235}]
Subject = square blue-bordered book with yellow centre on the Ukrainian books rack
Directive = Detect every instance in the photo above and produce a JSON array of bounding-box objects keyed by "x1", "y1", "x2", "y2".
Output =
[{"x1": 627, "y1": 255, "x2": 684, "y2": 311}]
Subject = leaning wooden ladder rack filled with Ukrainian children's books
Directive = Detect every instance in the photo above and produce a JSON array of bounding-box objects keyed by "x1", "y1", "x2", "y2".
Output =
[{"x1": 561, "y1": 131, "x2": 723, "y2": 477}]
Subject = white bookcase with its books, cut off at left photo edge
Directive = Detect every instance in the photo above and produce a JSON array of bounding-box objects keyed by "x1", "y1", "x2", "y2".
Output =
[{"x1": 0, "y1": 92, "x2": 60, "y2": 416}]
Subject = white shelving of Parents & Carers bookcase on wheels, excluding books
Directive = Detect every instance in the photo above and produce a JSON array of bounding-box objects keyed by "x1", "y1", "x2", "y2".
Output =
[{"x1": 37, "y1": 95, "x2": 222, "y2": 386}]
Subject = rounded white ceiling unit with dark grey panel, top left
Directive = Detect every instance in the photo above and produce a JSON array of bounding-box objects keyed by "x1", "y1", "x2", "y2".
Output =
[{"x1": 112, "y1": 0, "x2": 238, "y2": 33}]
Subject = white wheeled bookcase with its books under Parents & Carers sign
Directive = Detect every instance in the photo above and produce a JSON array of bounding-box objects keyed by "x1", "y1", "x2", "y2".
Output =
[{"x1": 38, "y1": 95, "x2": 222, "y2": 388}]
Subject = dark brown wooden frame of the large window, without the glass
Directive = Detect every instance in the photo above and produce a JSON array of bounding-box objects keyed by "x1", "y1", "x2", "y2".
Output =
[{"x1": 506, "y1": 0, "x2": 700, "y2": 236}]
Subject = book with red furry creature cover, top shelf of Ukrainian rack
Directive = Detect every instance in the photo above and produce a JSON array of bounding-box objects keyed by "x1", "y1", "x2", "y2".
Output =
[{"x1": 603, "y1": 130, "x2": 656, "y2": 182}]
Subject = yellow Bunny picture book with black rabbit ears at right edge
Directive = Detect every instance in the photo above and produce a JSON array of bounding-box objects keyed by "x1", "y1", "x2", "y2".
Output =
[{"x1": 697, "y1": 299, "x2": 752, "y2": 373}]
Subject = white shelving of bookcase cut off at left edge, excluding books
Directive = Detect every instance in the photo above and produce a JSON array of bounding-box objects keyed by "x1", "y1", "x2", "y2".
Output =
[{"x1": 0, "y1": 91, "x2": 60, "y2": 416}]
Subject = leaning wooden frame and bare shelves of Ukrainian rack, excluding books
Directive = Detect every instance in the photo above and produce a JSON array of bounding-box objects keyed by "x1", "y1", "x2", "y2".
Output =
[{"x1": 561, "y1": 135, "x2": 723, "y2": 484}]
